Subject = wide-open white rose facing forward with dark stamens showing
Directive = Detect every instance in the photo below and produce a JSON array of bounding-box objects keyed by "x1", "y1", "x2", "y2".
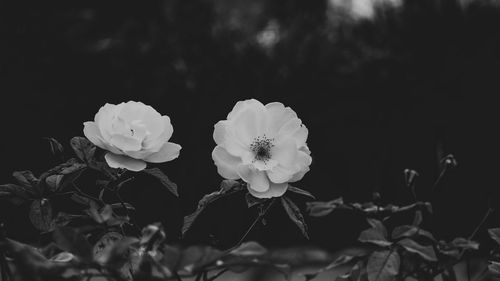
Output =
[{"x1": 212, "y1": 99, "x2": 312, "y2": 198}]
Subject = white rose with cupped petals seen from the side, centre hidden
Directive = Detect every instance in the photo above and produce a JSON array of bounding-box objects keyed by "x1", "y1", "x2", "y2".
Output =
[{"x1": 83, "y1": 101, "x2": 181, "y2": 172}]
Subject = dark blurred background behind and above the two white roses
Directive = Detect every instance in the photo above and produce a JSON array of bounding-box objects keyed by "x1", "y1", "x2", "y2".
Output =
[{"x1": 0, "y1": 0, "x2": 500, "y2": 248}]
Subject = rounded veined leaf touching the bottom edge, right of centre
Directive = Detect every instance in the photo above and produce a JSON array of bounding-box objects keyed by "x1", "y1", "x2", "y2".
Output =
[{"x1": 366, "y1": 250, "x2": 400, "y2": 281}]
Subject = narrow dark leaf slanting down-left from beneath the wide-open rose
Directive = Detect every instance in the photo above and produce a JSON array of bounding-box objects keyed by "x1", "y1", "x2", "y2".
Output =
[{"x1": 182, "y1": 180, "x2": 245, "y2": 235}]
